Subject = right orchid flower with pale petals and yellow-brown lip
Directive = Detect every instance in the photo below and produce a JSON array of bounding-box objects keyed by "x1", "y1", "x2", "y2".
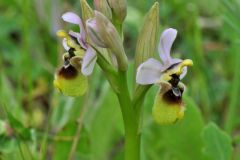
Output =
[{"x1": 136, "y1": 28, "x2": 193, "y2": 124}]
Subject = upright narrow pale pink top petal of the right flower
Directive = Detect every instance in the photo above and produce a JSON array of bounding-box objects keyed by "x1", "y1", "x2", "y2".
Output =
[{"x1": 158, "y1": 28, "x2": 177, "y2": 64}]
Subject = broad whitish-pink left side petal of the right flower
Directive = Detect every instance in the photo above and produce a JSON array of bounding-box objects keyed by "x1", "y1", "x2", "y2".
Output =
[{"x1": 136, "y1": 58, "x2": 162, "y2": 84}]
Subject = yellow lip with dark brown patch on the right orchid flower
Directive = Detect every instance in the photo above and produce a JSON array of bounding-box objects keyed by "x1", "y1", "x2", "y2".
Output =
[{"x1": 152, "y1": 82, "x2": 185, "y2": 125}]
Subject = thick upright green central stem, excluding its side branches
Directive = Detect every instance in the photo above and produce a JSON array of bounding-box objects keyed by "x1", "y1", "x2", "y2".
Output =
[{"x1": 117, "y1": 71, "x2": 140, "y2": 160}]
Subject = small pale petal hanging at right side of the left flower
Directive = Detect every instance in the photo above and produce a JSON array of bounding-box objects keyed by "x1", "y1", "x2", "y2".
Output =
[{"x1": 81, "y1": 47, "x2": 97, "y2": 76}]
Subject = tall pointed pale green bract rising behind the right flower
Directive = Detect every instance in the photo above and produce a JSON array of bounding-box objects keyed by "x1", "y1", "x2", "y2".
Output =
[{"x1": 135, "y1": 2, "x2": 159, "y2": 75}]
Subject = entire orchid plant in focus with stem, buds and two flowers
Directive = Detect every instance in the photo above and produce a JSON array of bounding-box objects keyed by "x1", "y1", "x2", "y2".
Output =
[{"x1": 54, "y1": 0, "x2": 193, "y2": 160}]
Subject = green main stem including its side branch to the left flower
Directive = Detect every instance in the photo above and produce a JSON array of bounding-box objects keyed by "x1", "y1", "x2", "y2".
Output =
[{"x1": 96, "y1": 45, "x2": 141, "y2": 160}]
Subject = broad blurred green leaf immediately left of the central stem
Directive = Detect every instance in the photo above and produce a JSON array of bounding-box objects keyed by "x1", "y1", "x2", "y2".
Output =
[{"x1": 87, "y1": 85, "x2": 124, "y2": 160}]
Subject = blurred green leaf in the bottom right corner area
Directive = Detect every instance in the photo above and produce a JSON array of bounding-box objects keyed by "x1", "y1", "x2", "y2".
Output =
[{"x1": 203, "y1": 123, "x2": 232, "y2": 160}]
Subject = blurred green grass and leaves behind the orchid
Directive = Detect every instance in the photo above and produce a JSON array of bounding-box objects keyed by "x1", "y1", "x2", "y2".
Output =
[{"x1": 0, "y1": 0, "x2": 240, "y2": 160}]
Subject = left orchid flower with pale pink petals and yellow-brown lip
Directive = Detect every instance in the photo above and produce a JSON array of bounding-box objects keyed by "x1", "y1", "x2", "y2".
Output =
[{"x1": 54, "y1": 12, "x2": 97, "y2": 96}]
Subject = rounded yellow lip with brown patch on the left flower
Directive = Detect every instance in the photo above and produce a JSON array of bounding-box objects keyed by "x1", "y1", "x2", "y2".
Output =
[{"x1": 53, "y1": 65, "x2": 88, "y2": 97}]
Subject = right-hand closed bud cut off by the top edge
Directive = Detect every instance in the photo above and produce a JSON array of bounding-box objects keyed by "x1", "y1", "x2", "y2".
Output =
[{"x1": 108, "y1": 0, "x2": 127, "y2": 23}]
